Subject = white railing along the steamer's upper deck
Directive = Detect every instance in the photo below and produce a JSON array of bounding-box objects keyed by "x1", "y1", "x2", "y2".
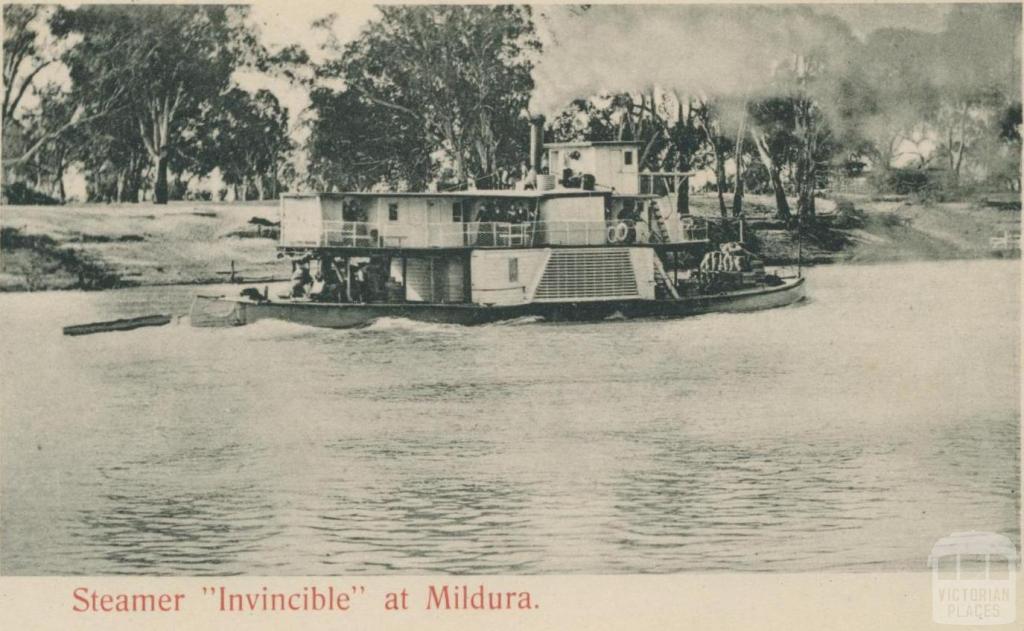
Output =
[{"x1": 305, "y1": 219, "x2": 708, "y2": 248}]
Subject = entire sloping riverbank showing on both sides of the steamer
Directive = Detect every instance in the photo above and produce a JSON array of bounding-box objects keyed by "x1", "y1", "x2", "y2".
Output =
[{"x1": 0, "y1": 195, "x2": 1020, "y2": 291}]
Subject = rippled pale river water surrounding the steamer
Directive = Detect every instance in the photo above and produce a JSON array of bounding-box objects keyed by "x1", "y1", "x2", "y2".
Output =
[{"x1": 0, "y1": 260, "x2": 1020, "y2": 575}]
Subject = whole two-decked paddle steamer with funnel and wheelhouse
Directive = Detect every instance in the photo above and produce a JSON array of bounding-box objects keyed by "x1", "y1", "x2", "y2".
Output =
[{"x1": 191, "y1": 121, "x2": 804, "y2": 328}]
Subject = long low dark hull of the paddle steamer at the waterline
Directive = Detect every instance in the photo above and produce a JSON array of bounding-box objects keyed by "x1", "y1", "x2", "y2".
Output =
[{"x1": 191, "y1": 279, "x2": 804, "y2": 329}]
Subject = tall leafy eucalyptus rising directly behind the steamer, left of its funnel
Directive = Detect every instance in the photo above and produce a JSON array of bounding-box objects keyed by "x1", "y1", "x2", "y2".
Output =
[{"x1": 319, "y1": 5, "x2": 540, "y2": 185}]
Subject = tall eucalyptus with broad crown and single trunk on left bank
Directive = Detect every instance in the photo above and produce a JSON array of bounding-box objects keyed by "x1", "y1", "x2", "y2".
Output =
[{"x1": 51, "y1": 5, "x2": 256, "y2": 204}]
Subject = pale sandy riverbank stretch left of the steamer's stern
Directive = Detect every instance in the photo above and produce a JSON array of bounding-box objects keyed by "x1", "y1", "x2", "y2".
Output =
[{"x1": 0, "y1": 202, "x2": 289, "y2": 291}]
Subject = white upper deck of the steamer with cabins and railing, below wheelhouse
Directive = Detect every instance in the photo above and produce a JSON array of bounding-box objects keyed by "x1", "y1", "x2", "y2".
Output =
[{"x1": 281, "y1": 190, "x2": 708, "y2": 250}]
